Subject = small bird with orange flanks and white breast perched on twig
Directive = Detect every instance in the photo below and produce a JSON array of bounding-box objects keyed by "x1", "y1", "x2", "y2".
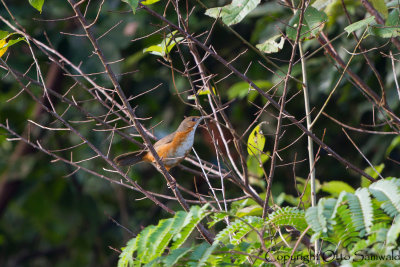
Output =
[{"x1": 114, "y1": 116, "x2": 203, "y2": 171}]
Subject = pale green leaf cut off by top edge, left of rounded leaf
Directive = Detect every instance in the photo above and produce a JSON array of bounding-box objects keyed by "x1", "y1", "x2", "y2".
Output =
[{"x1": 205, "y1": 0, "x2": 261, "y2": 26}]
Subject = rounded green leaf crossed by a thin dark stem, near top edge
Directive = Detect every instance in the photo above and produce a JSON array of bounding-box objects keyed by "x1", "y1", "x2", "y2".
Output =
[{"x1": 286, "y1": 6, "x2": 328, "y2": 40}]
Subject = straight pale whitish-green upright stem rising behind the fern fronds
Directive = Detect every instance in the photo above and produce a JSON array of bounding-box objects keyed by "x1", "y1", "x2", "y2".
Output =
[{"x1": 299, "y1": 42, "x2": 320, "y2": 264}]
